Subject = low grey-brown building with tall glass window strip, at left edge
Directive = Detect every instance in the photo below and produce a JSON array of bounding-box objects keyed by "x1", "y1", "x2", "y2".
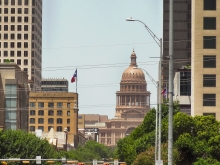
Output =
[{"x1": 0, "y1": 63, "x2": 29, "y2": 131}]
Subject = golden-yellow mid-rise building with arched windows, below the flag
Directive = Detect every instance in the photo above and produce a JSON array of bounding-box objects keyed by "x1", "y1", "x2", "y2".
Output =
[{"x1": 29, "y1": 92, "x2": 78, "y2": 147}]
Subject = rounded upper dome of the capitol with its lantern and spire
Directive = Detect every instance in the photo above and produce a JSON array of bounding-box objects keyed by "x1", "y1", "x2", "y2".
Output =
[{"x1": 121, "y1": 51, "x2": 146, "y2": 84}]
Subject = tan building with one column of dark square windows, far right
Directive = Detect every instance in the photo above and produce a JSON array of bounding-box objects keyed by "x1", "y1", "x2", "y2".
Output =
[{"x1": 191, "y1": 0, "x2": 220, "y2": 120}]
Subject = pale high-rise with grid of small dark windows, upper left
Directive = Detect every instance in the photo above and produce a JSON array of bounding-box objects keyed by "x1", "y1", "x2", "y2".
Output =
[{"x1": 0, "y1": 0, "x2": 42, "y2": 90}]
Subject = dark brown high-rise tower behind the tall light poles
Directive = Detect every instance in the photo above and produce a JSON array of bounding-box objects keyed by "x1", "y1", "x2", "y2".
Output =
[{"x1": 163, "y1": 0, "x2": 191, "y2": 86}]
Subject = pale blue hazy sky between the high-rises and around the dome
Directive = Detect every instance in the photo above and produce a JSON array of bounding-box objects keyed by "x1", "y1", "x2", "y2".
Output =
[{"x1": 42, "y1": 0, "x2": 163, "y2": 118}]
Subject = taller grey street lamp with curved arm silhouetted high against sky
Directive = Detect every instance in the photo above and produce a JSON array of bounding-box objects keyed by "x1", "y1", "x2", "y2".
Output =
[{"x1": 126, "y1": 18, "x2": 162, "y2": 164}]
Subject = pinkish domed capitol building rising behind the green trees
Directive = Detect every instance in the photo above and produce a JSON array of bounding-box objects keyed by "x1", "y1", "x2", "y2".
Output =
[{"x1": 99, "y1": 51, "x2": 150, "y2": 146}]
